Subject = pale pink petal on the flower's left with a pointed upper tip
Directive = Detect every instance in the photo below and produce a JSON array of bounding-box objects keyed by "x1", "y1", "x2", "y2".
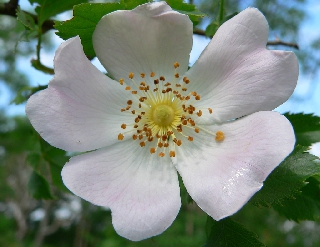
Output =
[{"x1": 26, "y1": 37, "x2": 130, "y2": 152}]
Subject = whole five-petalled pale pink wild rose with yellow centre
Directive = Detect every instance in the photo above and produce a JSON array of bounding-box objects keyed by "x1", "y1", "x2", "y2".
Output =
[{"x1": 26, "y1": 2, "x2": 298, "y2": 240}]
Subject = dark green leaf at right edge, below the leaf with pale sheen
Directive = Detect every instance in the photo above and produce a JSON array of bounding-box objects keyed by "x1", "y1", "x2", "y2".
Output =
[{"x1": 274, "y1": 177, "x2": 320, "y2": 222}]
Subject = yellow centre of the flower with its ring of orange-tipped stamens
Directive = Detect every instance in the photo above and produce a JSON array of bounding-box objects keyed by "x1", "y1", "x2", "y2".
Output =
[{"x1": 118, "y1": 62, "x2": 225, "y2": 158}]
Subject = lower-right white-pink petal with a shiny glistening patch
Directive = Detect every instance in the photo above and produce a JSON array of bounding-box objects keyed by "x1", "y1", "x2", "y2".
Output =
[{"x1": 175, "y1": 112, "x2": 295, "y2": 220}]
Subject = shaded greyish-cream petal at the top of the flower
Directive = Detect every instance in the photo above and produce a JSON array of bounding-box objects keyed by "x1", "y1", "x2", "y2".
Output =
[{"x1": 93, "y1": 2, "x2": 193, "y2": 82}]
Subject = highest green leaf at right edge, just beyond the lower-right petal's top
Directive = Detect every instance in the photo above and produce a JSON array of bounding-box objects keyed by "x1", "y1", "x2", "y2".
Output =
[{"x1": 284, "y1": 113, "x2": 320, "y2": 146}]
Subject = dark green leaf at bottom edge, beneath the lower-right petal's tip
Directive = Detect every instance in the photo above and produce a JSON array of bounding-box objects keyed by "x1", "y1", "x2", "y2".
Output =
[{"x1": 203, "y1": 217, "x2": 265, "y2": 247}]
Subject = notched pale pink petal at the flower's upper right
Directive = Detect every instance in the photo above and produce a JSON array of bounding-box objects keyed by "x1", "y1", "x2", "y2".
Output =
[{"x1": 187, "y1": 8, "x2": 299, "y2": 123}]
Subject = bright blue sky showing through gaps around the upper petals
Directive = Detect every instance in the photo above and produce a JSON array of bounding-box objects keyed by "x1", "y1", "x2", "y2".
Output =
[{"x1": 0, "y1": 0, "x2": 320, "y2": 155}]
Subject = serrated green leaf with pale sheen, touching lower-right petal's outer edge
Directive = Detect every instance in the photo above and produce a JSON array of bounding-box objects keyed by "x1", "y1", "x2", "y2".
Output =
[{"x1": 251, "y1": 145, "x2": 320, "y2": 207}]
